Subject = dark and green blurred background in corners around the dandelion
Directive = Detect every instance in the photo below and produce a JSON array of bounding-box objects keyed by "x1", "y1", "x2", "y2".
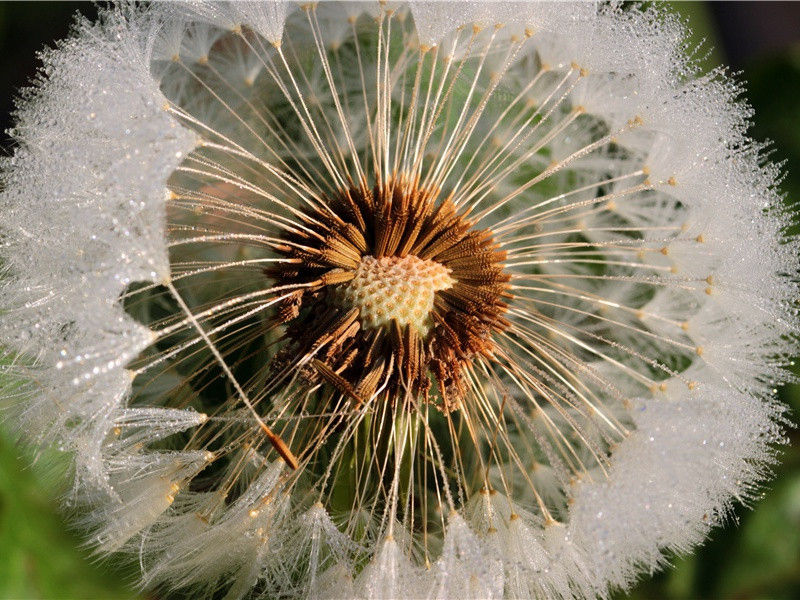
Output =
[{"x1": 0, "y1": 2, "x2": 800, "y2": 600}]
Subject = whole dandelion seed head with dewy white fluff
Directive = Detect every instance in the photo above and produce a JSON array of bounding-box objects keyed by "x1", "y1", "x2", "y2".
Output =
[{"x1": 0, "y1": 2, "x2": 796, "y2": 598}]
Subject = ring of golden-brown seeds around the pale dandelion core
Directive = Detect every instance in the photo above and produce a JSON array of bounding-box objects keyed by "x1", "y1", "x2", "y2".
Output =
[{"x1": 266, "y1": 177, "x2": 510, "y2": 411}]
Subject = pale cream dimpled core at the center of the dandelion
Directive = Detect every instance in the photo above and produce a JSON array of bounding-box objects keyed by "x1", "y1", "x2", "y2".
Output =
[{"x1": 336, "y1": 255, "x2": 455, "y2": 337}]
